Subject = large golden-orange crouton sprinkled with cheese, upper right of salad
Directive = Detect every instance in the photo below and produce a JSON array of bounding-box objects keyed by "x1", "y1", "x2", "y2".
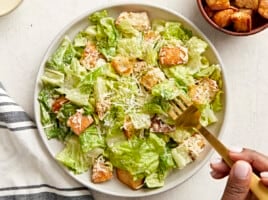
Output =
[{"x1": 159, "y1": 46, "x2": 188, "y2": 66}]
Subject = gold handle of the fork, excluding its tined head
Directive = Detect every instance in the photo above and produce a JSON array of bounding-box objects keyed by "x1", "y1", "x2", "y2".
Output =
[{"x1": 196, "y1": 125, "x2": 268, "y2": 200}]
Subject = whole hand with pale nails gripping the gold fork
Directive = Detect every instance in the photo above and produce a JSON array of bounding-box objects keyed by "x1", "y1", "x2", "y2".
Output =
[{"x1": 210, "y1": 148, "x2": 268, "y2": 200}]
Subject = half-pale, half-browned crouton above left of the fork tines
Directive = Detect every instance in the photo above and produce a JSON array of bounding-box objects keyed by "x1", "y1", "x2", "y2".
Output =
[{"x1": 140, "y1": 68, "x2": 165, "y2": 90}]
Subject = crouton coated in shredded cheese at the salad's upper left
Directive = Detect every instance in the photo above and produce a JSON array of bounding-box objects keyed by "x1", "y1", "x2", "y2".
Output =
[{"x1": 80, "y1": 43, "x2": 102, "y2": 69}]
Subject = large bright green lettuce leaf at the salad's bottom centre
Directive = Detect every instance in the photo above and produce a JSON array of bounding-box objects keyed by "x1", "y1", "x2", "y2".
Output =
[{"x1": 109, "y1": 133, "x2": 168, "y2": 179}]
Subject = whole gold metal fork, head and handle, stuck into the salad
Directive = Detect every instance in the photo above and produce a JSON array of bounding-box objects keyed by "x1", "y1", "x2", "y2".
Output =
[{"x1": 173, "y1": 101, "x2": 268, "y2": 200}]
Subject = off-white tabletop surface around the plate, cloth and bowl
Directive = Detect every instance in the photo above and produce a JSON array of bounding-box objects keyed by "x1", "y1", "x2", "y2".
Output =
[{"x1": 0, "y1": 0, "x2": 268, "y2": 200}]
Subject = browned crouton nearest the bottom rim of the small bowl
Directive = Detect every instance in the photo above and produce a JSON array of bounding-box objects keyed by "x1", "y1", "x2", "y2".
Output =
[{"x1": 232, "y1": 11, "x2": 252, "y2": 32}]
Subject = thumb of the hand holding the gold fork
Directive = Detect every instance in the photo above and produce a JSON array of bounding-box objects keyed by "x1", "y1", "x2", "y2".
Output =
[{"x1": 222, "y1": 160, "x2": 252, "y2": 200}]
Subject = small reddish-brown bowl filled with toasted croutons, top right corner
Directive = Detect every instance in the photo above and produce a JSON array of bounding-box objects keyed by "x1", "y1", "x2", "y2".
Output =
[{"x1": 197, "y1": 0, "x2": 268, "y2": 36}]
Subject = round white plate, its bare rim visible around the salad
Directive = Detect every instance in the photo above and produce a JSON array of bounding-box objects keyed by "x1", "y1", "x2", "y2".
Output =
[{"x1": 34, "y1": 3, "x2": 227, "y2": 197}]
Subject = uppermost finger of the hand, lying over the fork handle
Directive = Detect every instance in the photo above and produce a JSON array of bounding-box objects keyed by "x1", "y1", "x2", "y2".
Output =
[{"x1": 229, "y1": 148, "x2": 268, "y2": 172}]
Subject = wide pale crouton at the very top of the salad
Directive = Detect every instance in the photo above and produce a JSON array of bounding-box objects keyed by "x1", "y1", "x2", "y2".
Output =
[{"x1": 115, "y1": 12, "x2": 150, "y2": 31}]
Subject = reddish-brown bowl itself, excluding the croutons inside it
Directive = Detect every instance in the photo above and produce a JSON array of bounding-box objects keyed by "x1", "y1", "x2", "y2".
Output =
[{"x1": 196, "y1": 0, "x2": 268, "y2": 36}]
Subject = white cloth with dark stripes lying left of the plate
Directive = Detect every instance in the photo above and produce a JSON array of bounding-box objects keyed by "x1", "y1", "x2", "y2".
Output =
[{"x1": 0, "y1": 83, "x2": 93, "y2": 200}]
